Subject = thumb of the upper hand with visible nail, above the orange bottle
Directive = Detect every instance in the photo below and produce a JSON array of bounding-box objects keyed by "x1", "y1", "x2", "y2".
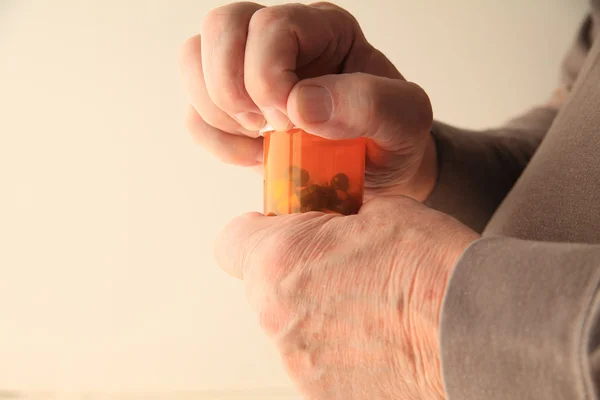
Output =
[{"x1": 287, "y1": 73, "x2": 433, "y2": 151}]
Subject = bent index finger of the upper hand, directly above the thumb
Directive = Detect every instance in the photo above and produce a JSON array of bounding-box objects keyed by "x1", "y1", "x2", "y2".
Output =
[{"x1": 244, "y1": 4, "x2": 358, "y2": 130}]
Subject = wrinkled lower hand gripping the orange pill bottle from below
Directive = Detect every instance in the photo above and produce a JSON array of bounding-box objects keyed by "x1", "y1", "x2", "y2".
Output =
[{"x1": 216, "y1": 196, "x2": 478, "y2": 400}]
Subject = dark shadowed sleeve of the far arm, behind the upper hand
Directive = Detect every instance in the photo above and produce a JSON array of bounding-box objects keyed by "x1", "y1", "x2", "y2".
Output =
[{"x1": 425, "y1": 17, "x2": 593, "y2": 232}]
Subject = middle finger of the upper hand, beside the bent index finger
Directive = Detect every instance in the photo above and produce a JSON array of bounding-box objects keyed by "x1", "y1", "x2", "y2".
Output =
[{"x1": 202, "y1": 2, "x2": 265, "y2": 131}]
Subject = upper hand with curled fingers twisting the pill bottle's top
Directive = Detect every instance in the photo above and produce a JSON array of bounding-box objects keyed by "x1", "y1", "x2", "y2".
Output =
[{"x1": 182, "y1": 3, "x2": 437, "y2": 200}]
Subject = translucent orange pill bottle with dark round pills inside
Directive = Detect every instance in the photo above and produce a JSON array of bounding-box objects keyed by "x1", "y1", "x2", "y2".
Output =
[{"x1": 262, "y1": 127, "x2": 366, "y2": 215}]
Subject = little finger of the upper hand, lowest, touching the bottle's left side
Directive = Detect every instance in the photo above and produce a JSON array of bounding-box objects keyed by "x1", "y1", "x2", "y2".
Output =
[{"x1": 187, "y1": 106, "x2": 263, "y2": 166}]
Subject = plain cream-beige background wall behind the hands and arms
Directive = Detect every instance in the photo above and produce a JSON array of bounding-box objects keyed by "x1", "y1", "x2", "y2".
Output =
[{"x1": 0, "y1": 0, "x2": 586, "y2": 399}]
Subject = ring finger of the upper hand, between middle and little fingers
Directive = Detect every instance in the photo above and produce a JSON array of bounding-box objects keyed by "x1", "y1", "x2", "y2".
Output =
[{"x1": 181, "y1": 36, "x2": 257, "y2": 137}]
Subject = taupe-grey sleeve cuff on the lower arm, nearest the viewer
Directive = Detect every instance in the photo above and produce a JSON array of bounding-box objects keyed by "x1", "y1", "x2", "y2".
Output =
[{"x1": 440, "y1": 237, "x2": 600, "y2": 400}]
